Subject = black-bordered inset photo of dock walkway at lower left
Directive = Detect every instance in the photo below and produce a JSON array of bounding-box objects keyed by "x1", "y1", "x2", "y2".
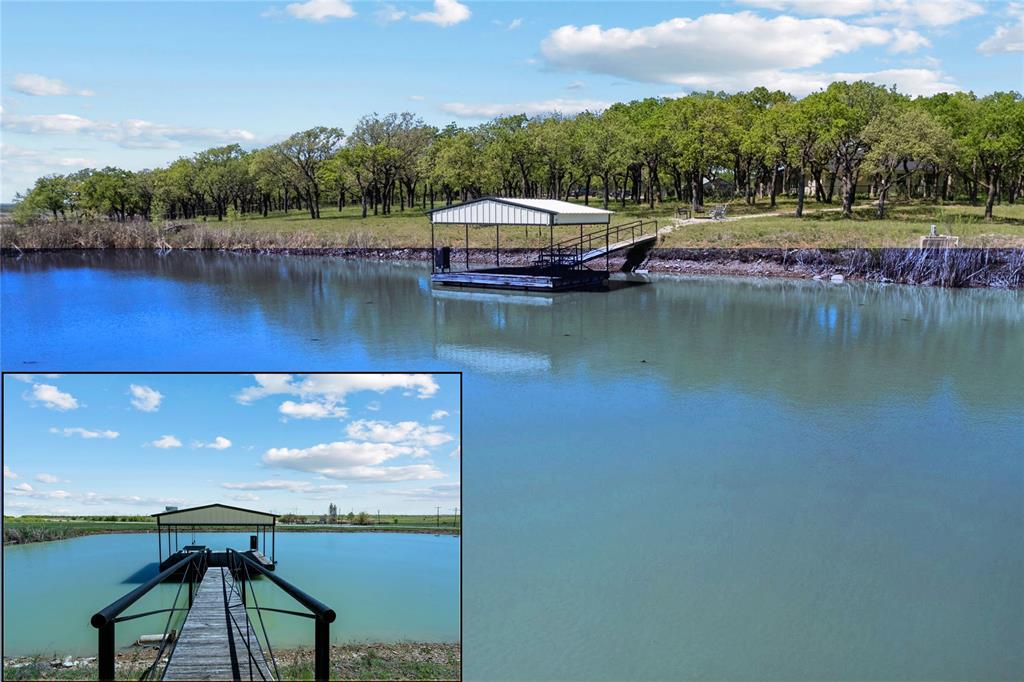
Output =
[{"x1": 3, "y1": 373, "x2": 462, "y2": 680}]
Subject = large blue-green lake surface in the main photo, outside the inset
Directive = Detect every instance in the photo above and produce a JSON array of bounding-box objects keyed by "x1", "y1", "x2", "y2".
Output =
[{"x1": 2, "y1": 253, "x2": 1024, "y2": 680}]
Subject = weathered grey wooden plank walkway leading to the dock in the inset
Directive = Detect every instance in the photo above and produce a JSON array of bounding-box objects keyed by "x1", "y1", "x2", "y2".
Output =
[{"x1": 163, "y1": 567, "x2": 273, "y2": 680}]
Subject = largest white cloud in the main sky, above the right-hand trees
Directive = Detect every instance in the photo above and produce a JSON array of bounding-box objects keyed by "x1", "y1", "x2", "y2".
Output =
[{"x1": 541, "y1": 11, "x2": 946, "y2": 92}]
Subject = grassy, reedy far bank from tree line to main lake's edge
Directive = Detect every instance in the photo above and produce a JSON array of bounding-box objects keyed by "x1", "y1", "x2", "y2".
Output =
[{"x1": 0, "y1": 204, "x2": 1024, "y2": 284}]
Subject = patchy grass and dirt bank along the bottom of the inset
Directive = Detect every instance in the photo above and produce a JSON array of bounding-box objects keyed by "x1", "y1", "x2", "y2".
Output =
[{"x1": 3, "y1": 642, "x2": 462, "y2": 680}]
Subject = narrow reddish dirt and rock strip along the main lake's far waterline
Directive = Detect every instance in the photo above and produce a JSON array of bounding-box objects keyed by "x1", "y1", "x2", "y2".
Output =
[{"x1": 0, "y1": 247, "x2": 1024, "y2": 289}]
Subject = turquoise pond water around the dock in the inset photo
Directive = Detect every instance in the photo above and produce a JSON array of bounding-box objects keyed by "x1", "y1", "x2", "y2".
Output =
[{"x1": 3, "y1": 532, "x2": 461, "y2": 655}]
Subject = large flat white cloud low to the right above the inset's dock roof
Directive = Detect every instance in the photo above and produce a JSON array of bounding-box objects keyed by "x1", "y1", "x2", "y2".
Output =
[{"x1": 263, "y1": 440, "x2": 444, "y2": 481}]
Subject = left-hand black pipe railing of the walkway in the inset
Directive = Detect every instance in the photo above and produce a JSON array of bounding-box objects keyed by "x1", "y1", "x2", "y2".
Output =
[{"x1": 90, "y1": 550, "x2": 209, "y2": 681}]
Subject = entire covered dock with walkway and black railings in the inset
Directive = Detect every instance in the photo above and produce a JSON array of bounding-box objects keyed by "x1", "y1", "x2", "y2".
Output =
[{"x1": 89, "y1": 504, "x2": 337, "y2": 681}]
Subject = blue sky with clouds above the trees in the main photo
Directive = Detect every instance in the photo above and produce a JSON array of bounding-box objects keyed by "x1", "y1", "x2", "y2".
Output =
[{"x1": 0, "y1": 0, "x2": 1024, "y2": 201}]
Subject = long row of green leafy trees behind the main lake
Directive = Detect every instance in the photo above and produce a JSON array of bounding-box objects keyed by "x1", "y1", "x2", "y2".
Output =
[{"x1": 15, "y1": 81, "x2": 1024, "y2": 221}]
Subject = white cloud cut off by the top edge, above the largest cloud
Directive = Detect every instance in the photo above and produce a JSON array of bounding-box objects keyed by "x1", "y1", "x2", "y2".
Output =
[{"x1": 740, "y1": 0, "x2": 985, "y2": 28}]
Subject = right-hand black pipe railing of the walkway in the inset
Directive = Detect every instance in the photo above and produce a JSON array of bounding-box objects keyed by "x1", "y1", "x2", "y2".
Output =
[{"x1": 227, "y1": 549, "x2": 337, "y2": 680}]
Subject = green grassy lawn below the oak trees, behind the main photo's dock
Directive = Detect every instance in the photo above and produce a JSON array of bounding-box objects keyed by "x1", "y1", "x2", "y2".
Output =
[{"x1": 192, "y1": 197, "x2": 1024, "y2": 249}]
